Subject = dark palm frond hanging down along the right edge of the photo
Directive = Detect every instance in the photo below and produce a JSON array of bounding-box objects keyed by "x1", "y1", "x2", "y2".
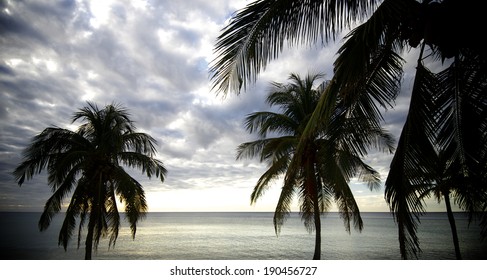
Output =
[{"x1": 434, "y1": 50, "x2": 487, "y2": 237}]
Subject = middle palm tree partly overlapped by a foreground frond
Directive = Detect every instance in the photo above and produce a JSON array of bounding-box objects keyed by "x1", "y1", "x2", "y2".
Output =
[{"x1": 237, "y1": 71, "x2": 393, "y2": 260}]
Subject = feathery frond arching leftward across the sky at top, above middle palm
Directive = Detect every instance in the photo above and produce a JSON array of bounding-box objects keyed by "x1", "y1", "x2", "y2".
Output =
[{"x1": 210, "y1": 0, "x2": 381, "y2": 93}]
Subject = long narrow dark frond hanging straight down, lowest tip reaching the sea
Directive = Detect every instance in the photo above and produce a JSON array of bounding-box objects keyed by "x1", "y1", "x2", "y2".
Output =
[{"x1": 385, "y1": 60, "x2": 437, "y2": 258}]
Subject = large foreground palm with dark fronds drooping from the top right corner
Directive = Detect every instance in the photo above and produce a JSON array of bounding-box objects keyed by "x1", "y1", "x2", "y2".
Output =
[{"x1": 210, "y1": 0, "x2": 487, "y2": 259}]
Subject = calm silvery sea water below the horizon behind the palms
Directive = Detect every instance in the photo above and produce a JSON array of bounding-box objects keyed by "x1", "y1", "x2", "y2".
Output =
[{"x1": 0, "y1": 212, "x2": 487, "y2": 260}]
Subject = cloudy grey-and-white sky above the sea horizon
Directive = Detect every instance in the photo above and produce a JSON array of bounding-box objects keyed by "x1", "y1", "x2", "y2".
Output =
[{"x1": 0, "y1": 0, "x2": 454, "y2": 212}]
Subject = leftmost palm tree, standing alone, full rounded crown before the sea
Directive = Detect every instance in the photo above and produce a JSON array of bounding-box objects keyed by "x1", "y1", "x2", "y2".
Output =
[{"x1": 13, "y1": 102, "x2": 167, "y2": 260}]
